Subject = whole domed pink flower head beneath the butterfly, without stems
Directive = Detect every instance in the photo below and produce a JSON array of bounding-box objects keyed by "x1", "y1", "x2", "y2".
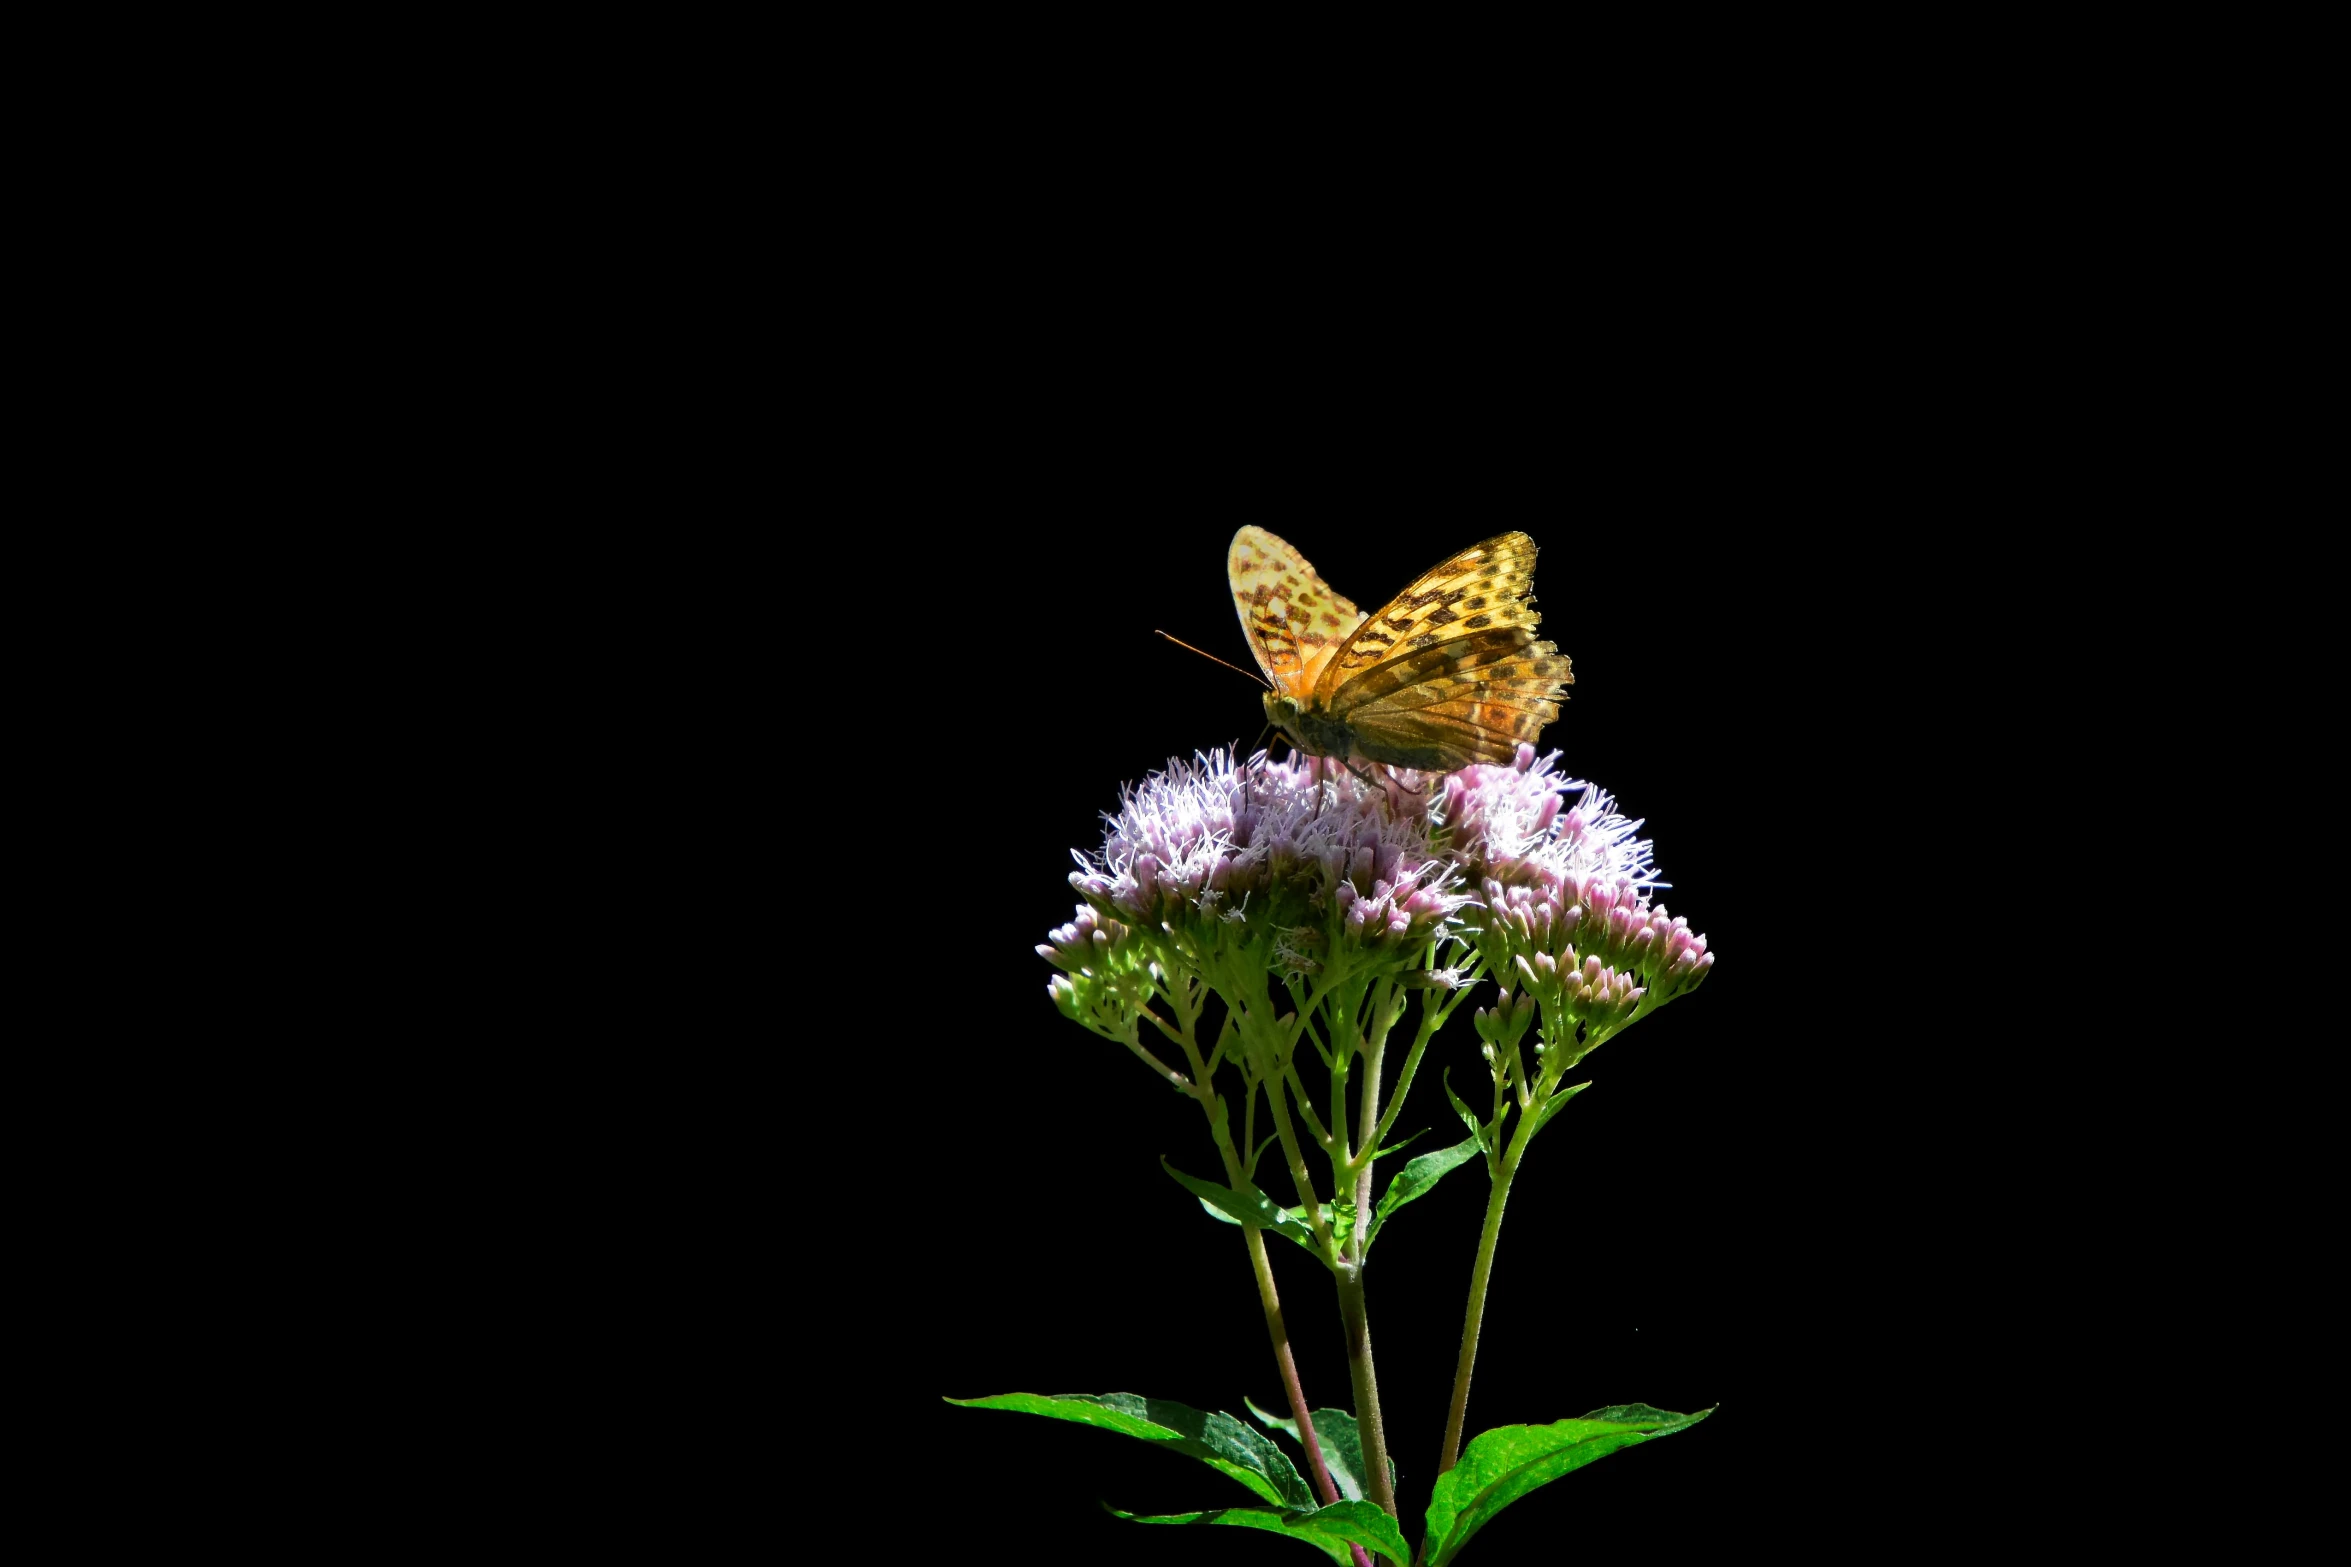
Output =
[{"x1": 1037, "y1": 745, "x2": 1714, "y2": 1043}]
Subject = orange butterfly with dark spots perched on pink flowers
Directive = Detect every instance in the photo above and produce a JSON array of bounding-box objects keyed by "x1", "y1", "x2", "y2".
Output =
[{"x1": 1227, "y1": 529, "x2": 1575, "y2": 771}]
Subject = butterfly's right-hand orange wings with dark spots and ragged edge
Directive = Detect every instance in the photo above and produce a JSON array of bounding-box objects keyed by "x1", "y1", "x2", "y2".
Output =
[{"x1": 1312, "y1": 533, "x2": 1575, "y2": 768}]
